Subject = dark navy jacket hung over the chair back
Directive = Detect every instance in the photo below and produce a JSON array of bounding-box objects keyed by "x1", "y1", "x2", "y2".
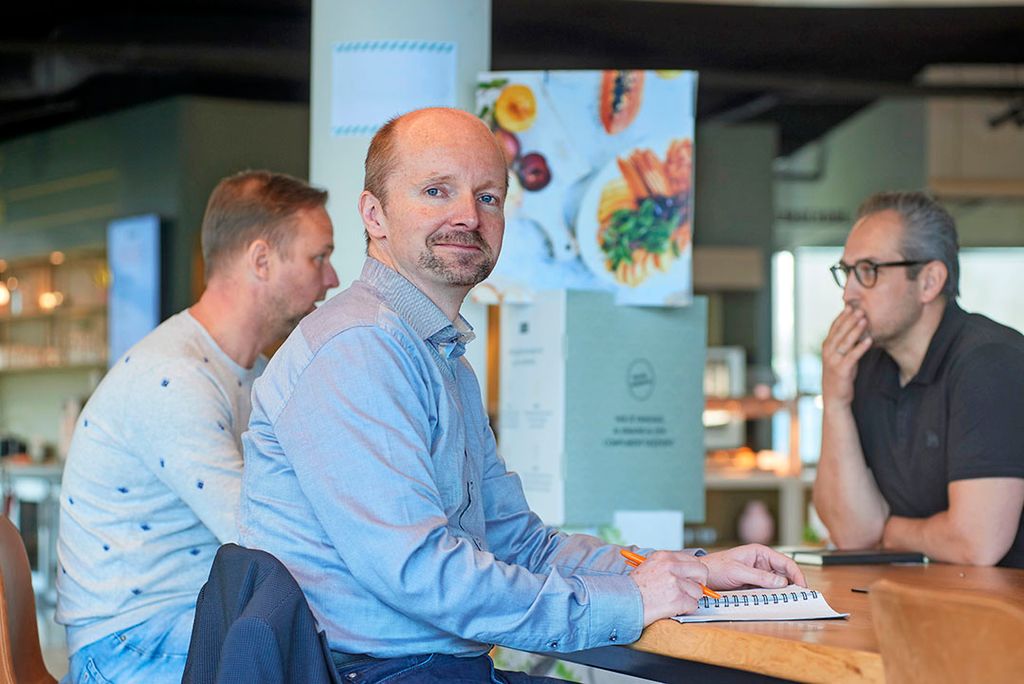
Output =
[{"x1": 181, "y1": 544, "x2": 339, "y2": 684}]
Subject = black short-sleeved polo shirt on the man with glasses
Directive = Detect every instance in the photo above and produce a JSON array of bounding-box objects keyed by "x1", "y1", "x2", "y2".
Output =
[{"x1": 853, "y1": 302, "x2": 1024, "y2": 567}]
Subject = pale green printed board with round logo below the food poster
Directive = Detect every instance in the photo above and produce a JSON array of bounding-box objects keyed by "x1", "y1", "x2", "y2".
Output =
[{"x1": 498, "y1": 290, "x2": 708, "y2": 527}]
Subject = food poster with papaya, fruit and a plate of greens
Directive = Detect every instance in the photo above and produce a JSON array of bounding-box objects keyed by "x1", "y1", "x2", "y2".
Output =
[{"x1": 477, "y1": 70, "x2": 696, "y2": 306}]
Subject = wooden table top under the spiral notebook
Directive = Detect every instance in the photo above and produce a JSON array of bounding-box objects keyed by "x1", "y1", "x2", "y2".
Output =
[{"x1": 565, "y1": 563, "x2": 1024, "y2": 684}]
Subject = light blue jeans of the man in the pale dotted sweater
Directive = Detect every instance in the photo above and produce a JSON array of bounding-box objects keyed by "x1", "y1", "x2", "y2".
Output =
[{"x1": 60, "y1": 607, "x2": 195, "y2": 684}]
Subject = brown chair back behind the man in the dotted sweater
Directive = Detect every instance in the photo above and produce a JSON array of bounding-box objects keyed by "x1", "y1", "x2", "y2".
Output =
[{"x1": 0, "y1": 515, "x2": 56, "y2": 684}]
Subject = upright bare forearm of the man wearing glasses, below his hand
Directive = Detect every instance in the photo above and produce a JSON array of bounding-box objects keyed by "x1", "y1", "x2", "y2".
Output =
[{"x1": 814, "y1": 404, "x2": 889, "y2": 549}]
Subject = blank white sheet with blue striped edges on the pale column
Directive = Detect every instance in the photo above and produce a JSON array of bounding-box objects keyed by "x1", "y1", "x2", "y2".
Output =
[{"x1": 331, "y1": 40, "x2": 456, "y2": 136}]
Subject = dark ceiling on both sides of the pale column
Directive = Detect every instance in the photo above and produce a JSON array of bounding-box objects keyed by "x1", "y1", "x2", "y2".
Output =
[{"x1": 0, "y1": 0, "x2": 1024, "y2": 154}]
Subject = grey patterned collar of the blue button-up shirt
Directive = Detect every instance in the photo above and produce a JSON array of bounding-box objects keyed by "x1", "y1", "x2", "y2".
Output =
[{"x1": 359, "y1": 257, "x2": 476, "y2": 358}]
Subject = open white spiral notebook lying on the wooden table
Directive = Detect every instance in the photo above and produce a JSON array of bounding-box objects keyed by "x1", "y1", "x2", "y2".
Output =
[{"x1": 673, "y1": 585, "x2": 850, "y2": 623}]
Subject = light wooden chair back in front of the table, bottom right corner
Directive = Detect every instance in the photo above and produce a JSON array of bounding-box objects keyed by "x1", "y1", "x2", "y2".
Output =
[{"x1": 870, "y1": 580, "x2": 1024, "y2": 684}]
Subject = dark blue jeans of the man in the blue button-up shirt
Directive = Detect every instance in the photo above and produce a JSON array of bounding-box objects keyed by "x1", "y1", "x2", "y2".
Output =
[{"x1": 338, "y1": 653, "x2": 564, "y2": 684}]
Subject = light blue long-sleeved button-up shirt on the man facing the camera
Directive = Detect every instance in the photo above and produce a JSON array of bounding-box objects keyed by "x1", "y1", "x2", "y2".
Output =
[{"x1": 239, "y1": 259, "x2": 643, "y2": 657}]
